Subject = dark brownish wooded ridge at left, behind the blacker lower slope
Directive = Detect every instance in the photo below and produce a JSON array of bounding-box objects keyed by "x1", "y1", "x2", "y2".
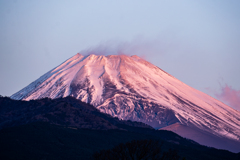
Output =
[{"x1": 0, "y1": 97, "x2": 150, "y2": 130}]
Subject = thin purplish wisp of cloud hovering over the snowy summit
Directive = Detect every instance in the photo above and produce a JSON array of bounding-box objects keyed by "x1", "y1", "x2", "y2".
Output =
[{"x1": 79, "y1": 36, "x2": 174, "y2": 59}]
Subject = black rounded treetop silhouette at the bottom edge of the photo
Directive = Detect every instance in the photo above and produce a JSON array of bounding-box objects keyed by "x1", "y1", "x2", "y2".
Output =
[{"x1": 93, "y1": 140, "x2": 183, "y2": 160}]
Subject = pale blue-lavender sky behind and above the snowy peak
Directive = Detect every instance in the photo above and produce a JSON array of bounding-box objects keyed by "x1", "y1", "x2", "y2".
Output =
[{"x1": 0, "y1": 0, "x2": 240, "y2": 110}]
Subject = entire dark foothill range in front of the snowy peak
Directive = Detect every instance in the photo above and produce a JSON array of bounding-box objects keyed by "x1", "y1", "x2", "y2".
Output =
[{"x1": 0, "y1": 97, "x2": 240, "y2": 160}]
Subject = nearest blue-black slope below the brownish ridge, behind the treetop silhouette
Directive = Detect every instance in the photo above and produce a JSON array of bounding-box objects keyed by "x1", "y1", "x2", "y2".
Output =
[{"x1": 0, "y1": 122, "x2": 239, "y2": 160}]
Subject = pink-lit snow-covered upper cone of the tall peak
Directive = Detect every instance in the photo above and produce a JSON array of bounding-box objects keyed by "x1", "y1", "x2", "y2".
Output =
[{"x1": 11, "y1": 54, "x2": 240, "y2": 141}]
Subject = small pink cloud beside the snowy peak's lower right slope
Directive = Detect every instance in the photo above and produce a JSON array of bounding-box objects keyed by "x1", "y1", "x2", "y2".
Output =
[{"x1": 215, "y1": 84, "x2": 240, "y2": 111}]
